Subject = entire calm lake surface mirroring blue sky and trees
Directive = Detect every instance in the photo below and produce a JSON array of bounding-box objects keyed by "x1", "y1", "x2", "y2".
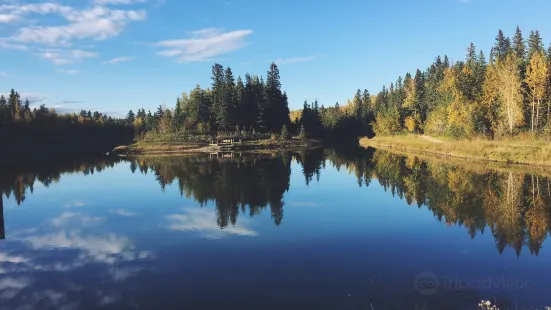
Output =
[{"x1": 0, "y1": 150, "x2": 551, "y2": 310}]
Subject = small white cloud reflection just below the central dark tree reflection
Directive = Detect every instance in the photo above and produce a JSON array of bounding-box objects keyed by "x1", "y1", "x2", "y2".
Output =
[{"x1": 167, "y1": 208, "x2": 258, "y2": 239}]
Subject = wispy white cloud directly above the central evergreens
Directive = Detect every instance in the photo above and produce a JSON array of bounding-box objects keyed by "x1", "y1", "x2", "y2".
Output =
[{"x1": 154, "y1": 28, "x2": 253, "y2": 63}]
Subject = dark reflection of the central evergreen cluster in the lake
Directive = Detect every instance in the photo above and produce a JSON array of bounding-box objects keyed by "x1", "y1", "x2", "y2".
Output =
[{"x1": 137, "y1": 154, "x2": 291, "y2": 227}]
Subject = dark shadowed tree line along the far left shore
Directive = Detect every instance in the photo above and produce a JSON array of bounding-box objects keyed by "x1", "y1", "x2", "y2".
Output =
[{"x1": 0, "y1": 89, "x2": 133, "y2": 160}]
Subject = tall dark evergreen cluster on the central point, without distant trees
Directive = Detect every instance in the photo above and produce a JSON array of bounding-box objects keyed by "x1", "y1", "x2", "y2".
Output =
[{"x1": 126, "y1": 63, "x2": 296, "y2": 138}]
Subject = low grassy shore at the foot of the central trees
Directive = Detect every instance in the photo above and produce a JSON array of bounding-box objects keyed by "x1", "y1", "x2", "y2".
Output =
[{"x1": 114, "y1": 139, "x2": 321, "y2": 154}]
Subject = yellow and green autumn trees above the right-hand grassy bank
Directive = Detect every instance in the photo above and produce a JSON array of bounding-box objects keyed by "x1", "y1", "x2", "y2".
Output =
[{"x1": 362, "y1": 27, "x2": 551, "y2": 138}]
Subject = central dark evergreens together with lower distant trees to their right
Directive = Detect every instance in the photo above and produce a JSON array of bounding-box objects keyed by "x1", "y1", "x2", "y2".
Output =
[{"x1": 126, "y1": 63, "x2": 371, "y2": 142}]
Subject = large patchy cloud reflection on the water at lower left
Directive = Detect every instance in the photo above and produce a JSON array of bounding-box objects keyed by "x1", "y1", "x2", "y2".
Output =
[{"x1": 0, "y1": 230, "x2": 154, "y2": 310}]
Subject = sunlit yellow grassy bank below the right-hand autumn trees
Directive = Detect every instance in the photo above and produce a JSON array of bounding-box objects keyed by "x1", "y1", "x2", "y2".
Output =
[{"x1": 360, "y1": 134, "x2": 551, "y2": 166}]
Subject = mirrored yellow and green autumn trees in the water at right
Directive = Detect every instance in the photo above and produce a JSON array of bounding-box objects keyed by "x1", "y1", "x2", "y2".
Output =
[{"x1": 336, "y1": 151, "x2": 551, "y2": 255}]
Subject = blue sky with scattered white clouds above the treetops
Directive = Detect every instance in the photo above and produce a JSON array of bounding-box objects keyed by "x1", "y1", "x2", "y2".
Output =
[{"x1": 0, "y1": 0, "x2": 551, "y2": 115}]
